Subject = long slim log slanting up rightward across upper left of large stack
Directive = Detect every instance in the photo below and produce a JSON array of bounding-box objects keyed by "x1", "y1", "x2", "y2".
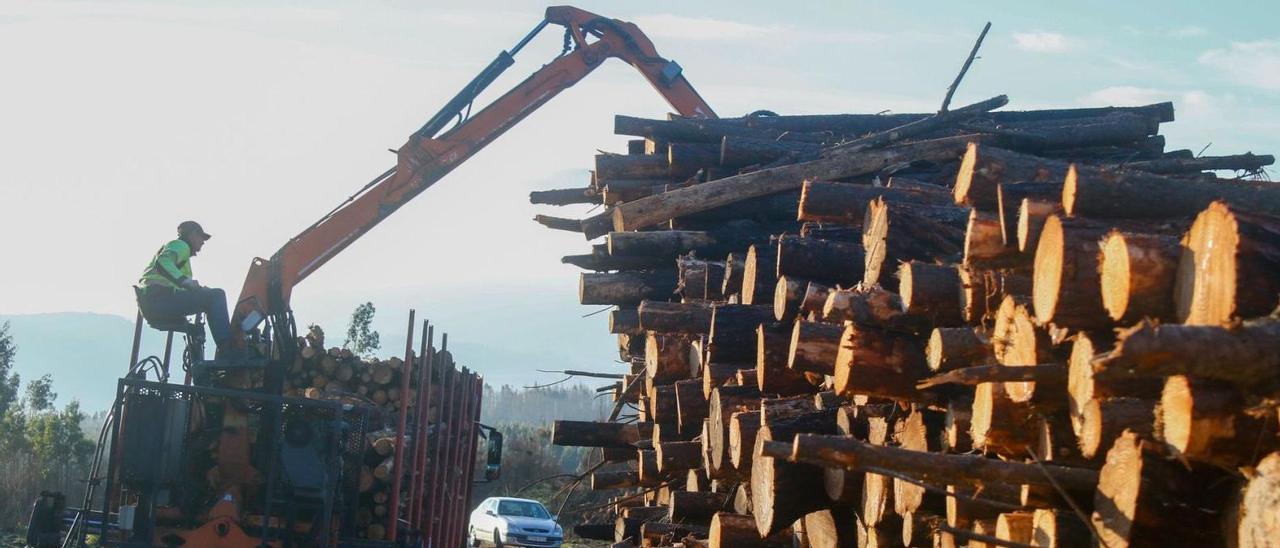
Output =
[{"x1": 609, "y1": 138, "x2": 966, "y2": 232}]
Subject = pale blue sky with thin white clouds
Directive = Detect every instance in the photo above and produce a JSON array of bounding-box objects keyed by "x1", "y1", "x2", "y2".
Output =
[{"x1": 0, "y1": 0, "x2": 1280, "y2": 384}]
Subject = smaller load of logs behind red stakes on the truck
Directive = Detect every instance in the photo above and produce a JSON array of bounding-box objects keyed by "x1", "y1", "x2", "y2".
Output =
[{"x1": 284, "y1": 321, "x2": 484, "y2": 545}]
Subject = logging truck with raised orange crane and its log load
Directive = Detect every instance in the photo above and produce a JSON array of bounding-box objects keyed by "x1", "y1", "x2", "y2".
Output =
[{"x1": 28, "y1": 6, "x2": 716, "y2": 548}]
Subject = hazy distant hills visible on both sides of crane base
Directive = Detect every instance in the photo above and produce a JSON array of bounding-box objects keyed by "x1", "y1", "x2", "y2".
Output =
[{"x1": 0, "y1": 286, "x2": 620, "y2": 412}]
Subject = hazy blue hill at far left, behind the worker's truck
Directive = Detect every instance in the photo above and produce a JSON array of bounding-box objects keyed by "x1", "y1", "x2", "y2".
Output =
[{"x1": 0, "y1": 312, "x2": 170, "y2": 412}]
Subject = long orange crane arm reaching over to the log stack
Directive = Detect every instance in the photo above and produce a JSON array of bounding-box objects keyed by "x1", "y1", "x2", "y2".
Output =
[{"x1": 233, "y1": 6, "x2": 716, "y2": 332}]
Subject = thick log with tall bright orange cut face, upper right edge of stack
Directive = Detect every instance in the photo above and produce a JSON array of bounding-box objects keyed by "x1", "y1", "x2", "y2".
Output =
[{"x1": 1174, "y1": 203, "x2": 1280, "y2": 325}]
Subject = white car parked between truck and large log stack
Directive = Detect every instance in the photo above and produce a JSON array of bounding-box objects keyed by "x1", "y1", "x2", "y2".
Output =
[{"x1": 467, "y1": 497, "x2": 564, "y2": 548}]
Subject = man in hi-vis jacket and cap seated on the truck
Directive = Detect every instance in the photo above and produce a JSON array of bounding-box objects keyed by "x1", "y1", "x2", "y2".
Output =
[{"x1": 138, "y1": 220, "x2": 242, "y2": 361}]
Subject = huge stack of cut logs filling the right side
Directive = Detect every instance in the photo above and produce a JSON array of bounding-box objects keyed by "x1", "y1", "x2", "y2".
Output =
[{"x1": 531, "y1": 96, "x2": 1280, "y2": 548}]
